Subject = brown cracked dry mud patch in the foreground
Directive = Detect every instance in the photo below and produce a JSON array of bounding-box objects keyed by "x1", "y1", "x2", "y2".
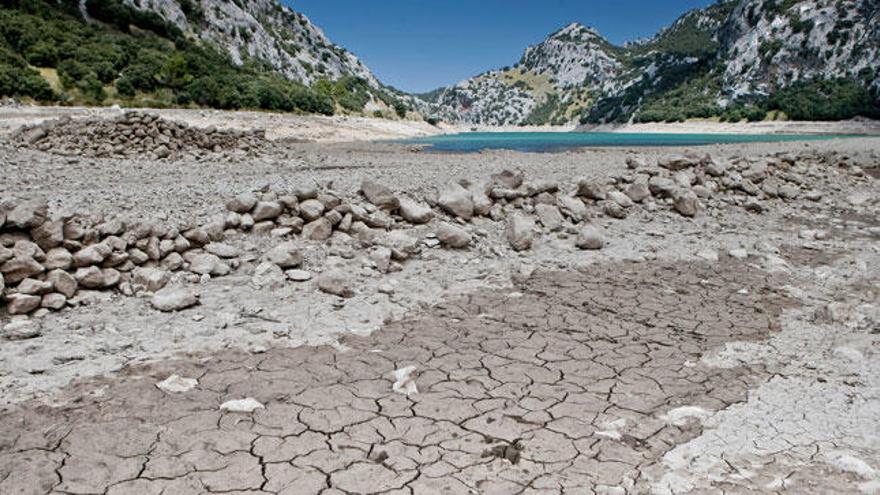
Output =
[{"x1": 0, "y1": 261, "x2": 794, "y2": 494}]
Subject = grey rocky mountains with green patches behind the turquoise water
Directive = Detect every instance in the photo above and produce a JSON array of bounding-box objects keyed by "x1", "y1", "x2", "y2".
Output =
[{"x1": 424, "y1": 0, "x2": 880, "y2": 125}]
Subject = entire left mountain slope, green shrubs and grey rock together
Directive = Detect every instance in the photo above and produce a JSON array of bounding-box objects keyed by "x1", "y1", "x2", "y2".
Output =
[{"x1": 0, "y1": 0, "x2": 407, "y2": 117}]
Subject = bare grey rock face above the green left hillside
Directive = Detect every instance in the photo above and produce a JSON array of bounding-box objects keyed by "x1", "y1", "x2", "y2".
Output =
[{"x1": 124, "y1": 0, "x2": 379, "y2": 87}]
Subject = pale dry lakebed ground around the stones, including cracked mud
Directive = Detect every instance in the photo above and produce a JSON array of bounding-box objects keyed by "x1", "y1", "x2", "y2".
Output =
[{"x1": 0, "y1": 108, "x2": 880, "y2": 495}]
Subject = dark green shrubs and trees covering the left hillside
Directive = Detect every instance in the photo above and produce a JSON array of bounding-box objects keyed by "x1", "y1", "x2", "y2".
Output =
[{"x1": 0, "y1": 0, "x2": 405, "y2": 115}]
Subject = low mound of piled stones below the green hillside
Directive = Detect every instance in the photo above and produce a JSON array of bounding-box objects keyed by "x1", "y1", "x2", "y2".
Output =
[{"x1": 12, "y1": 111, "x2": 266, "y2": 159}]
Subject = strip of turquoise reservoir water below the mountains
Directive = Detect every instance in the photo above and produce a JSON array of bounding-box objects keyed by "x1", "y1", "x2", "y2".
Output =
[{"x1": 404, "y1": 132, "x2": 848, "y2": 153}]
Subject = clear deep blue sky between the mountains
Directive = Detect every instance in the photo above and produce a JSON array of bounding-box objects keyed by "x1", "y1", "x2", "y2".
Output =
[{"x1": 283, "y1": 0, "x2": 714, "y2": 92}]
